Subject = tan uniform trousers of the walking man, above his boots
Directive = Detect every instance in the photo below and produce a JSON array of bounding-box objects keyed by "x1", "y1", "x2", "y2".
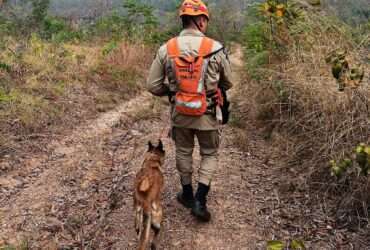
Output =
[{"x1": 173, "y1": 127, "x2": 220, "y2": 186}]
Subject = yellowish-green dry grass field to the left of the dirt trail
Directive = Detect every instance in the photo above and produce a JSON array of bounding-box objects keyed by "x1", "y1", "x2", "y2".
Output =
[{"x1": 0, "y1": 36, "x2": 152, "y2": 156}]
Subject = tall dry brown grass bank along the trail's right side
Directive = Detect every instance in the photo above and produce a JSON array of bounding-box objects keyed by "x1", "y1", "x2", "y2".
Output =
[{"x1": 238, "y1": 5, "x2": 370, "y2": 232}]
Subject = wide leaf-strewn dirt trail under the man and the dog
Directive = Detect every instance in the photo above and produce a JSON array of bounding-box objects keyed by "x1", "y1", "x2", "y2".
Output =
[{"x1": 0, "y1": 46, "x2": 330, "y2": 250}]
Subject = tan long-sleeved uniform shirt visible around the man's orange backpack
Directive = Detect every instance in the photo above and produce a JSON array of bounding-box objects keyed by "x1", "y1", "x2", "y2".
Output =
[{"x1": 147, "y1": 29, "x2": 233, "y2": 130}]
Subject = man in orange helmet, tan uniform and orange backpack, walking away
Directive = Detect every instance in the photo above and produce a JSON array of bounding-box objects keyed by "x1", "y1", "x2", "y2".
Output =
[{"x1": 147, "y1": 0, "x2": 233, "y2": 222}]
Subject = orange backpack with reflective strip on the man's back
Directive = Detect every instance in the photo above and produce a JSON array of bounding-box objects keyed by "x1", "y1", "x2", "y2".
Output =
[{"x1": 167, "y1": 37, "x2": 213, "y2": 116}]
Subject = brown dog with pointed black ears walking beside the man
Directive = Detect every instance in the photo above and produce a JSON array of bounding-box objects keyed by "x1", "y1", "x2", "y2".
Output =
[{"x1": 134, "y1": 141, "x2": 165, "y2": 250}]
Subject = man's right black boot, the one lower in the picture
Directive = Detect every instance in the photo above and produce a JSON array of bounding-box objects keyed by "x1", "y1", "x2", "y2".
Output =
[{"x1": 191, "y1": 183, "x2": 211, "y2": 222}]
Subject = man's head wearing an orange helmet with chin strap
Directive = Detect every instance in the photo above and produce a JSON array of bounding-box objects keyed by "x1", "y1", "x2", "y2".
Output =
[{"x1": 180, "y1": 0, "x2": 209, "y2": 33}]
